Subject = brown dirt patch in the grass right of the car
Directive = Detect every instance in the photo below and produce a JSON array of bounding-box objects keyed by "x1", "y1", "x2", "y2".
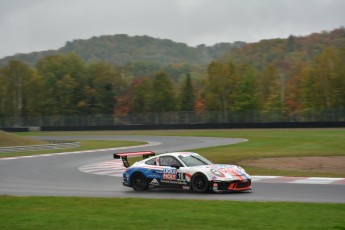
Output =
[{"x1": 241, "y1": 156, "x2": 345, "y2": 174}]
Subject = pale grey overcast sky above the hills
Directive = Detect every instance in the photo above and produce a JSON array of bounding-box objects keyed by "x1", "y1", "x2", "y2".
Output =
[{"x1": 0, "y1": 0, "x2": 345, "y2": 58}]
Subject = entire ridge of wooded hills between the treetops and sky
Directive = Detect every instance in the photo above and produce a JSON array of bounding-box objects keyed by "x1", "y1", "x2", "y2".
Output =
[{"x1": 0, "y1": 27, "x2": 345, "y2": 69}]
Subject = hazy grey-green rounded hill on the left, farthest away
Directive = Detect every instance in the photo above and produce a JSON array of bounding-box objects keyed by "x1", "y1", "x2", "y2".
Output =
[{"x1": 0, "y1": 34, "x2": 245, "y2": 66}]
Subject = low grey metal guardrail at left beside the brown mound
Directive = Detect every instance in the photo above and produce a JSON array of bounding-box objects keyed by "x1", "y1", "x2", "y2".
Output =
[{"x1": 0, "y1": 142, "x2": 80, "y2": 153}]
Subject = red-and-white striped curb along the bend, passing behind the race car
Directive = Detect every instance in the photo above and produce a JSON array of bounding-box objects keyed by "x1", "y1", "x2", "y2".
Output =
[{"x1": 78, "y1": 160, "x2": 345, "y2": 185}]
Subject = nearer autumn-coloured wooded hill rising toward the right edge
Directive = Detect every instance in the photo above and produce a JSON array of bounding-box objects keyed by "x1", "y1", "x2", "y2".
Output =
[{"x1": 224, "y1": 27, "x2": 345, "y2": 70}]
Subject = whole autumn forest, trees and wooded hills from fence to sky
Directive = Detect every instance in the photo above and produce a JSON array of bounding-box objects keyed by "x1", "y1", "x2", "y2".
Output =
[{"x1": 0, "y1": 28, "x2": 345, "y2": 127}]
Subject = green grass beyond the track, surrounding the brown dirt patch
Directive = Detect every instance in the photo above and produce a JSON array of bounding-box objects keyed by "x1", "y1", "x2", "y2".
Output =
[{"x1": 14, "y1": 128, "x2": 345, "y2": 177}]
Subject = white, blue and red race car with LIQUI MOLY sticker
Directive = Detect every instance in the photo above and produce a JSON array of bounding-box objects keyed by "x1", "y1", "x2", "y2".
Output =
[{"x1": 114, "y1": 151, "x2": 251, "y2": 193}]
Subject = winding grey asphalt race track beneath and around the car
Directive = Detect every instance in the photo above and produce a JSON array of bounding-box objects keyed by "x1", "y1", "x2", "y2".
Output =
[{"x1": 0, "y1": 136, "x2": 345, "y2": 203}]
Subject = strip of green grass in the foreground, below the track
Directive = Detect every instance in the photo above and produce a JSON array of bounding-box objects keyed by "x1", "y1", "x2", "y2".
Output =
[{"x1": 0, "y1": 196, "x2": 345, "y2": 230}]
